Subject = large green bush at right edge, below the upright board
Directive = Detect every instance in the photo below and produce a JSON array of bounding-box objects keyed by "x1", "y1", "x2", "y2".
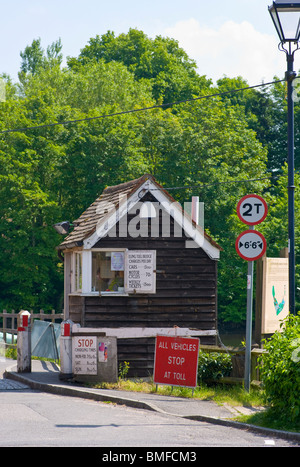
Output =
[{"x1": 259, "y1": 314, "x2": 300, "y2": 421}]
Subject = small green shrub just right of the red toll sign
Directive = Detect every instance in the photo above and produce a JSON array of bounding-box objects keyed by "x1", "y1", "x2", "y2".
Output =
[{"x1": 198, "y1": 351, "x2": 232, "y2": 382}]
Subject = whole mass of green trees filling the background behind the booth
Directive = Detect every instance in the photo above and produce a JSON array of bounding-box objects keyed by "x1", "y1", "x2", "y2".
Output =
[{"x1": 0, "y1": 29, "x2": 300, "y2": 323}]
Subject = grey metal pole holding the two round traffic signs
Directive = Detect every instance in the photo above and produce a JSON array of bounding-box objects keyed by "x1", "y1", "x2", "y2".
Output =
[{"x1": 244, "y1": 226, "x2": 254, "y2": 392}]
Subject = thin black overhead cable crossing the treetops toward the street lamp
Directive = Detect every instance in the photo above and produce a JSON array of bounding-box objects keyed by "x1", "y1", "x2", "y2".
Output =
[{"x1": 0, "y1": 76, "x2": 292, "y2": 134}]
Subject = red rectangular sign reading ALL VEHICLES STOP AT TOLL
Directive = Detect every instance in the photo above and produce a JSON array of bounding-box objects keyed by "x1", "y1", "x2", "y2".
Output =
[{"x1": 153, "y1": 336, "x2": 200, "y2": 388}]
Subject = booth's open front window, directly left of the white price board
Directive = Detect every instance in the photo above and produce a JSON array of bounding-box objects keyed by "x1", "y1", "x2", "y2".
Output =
[{"x1": 92, "y1": 251, "x2": 125, "y2": 293}]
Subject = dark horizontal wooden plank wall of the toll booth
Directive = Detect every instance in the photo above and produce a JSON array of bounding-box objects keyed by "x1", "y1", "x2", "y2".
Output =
[{"x1": 70, "y1": 196, "x2": 217, "y2": 376}]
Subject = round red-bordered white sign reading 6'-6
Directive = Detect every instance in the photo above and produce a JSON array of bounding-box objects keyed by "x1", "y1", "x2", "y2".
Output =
[{"x1": 235, "y1": 230, "x2": 267, "y2": 261}]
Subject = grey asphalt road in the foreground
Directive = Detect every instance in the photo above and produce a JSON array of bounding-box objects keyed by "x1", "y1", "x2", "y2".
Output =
[{"x1": 0, "y1": 362, "x2": 297, "y2": 448}]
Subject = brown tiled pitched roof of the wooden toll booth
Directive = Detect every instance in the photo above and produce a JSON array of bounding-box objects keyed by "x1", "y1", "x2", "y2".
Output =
[{"x1": 57, "y1": 174, "x2": 222, "y2": 256}]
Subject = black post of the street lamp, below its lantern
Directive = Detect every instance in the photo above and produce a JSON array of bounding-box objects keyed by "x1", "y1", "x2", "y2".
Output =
[{"x1": 286, "y1": 50, "x2": 296, "y2": 314}]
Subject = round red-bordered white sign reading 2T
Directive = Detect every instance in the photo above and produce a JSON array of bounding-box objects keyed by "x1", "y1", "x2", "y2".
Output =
[{"x1": 236, "y1": 194, "x2": 268, "y2": 225}]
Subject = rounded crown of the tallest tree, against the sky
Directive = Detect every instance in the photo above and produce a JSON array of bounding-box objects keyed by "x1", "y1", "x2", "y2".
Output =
[{"x1": 68, "y1": 29, "x2": 210, "y2": 103}]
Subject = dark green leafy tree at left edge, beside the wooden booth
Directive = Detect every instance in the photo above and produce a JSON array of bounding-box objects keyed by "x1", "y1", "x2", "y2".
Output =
[{"x1": 0, "y1": 126, "x2": 62, "y2": 308}]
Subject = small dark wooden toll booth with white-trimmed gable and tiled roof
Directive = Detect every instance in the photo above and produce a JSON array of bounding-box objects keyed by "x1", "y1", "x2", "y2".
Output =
[{"x1": 58, "y1": 175, "x2": 221, "y2": 377}]
